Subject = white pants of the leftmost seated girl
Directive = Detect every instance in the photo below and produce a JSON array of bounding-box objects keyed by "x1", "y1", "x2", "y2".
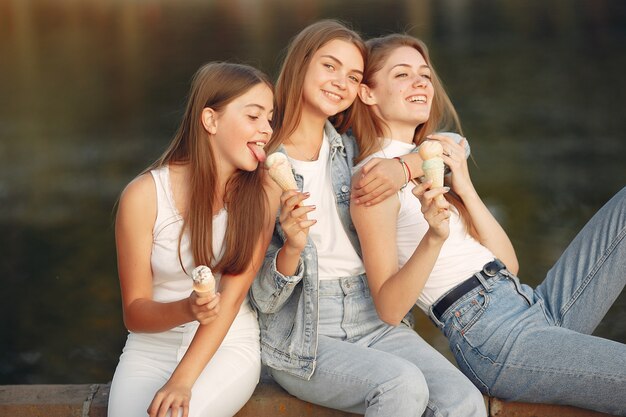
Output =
[{"x1": 108, "y1": 302, "x2": 261, "y2": 417}]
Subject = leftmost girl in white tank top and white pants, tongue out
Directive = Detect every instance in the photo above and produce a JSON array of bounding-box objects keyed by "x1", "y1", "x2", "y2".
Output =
[{"x1": 108, "y1": 63, "x2": 278, "y2": 417}]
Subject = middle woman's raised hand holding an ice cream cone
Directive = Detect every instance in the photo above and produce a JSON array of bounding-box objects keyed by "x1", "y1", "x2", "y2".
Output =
[{"x1": 279, "y1": 190, "x2": 317, "y2": 252}]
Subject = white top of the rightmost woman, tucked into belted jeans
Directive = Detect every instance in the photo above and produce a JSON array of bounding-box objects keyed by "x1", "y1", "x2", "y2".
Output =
[{"x1": 354, "y1": 139, "x2": 495, "y2": 312}]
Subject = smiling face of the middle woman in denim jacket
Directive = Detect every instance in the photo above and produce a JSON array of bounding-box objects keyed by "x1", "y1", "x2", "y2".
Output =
[{"x1": 302, "y1": 39, "x2": 364, "y2": 119}]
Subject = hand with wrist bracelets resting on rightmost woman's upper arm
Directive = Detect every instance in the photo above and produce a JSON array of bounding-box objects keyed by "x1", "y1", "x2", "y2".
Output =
[{"x1": 352, "y1": 158, "x2": 406, "y2": 206}]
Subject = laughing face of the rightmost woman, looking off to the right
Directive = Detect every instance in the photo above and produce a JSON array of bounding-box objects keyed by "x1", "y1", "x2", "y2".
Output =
[{"x1": 360, "y1": 46, "x2": 434, "y2": 140}]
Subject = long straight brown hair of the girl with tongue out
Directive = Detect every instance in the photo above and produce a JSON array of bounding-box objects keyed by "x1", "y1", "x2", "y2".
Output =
[{"x1": 144, "y1": 62, "x2": 272, "y2": 274}]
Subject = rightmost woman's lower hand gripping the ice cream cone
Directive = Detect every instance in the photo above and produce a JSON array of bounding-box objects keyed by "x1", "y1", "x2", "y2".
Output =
[{"x1": 413, "y1": 181, "x2": 450, "y2": 240}]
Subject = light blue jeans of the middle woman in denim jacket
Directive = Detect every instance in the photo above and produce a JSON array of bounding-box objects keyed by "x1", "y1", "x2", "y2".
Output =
[{"x1": 270, "y1": 276, "x2": 487, "y2": 417}]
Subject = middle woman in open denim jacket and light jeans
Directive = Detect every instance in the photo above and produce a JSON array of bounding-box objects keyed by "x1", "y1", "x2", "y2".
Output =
[{"x1": 251, "y1": 21, "x2": 486, "y2": 416}]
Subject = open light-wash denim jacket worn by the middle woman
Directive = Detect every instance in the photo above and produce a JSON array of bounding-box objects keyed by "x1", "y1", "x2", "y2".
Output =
[{"x1": 250, "y1": 121, "x2": 410, "y2": 379}]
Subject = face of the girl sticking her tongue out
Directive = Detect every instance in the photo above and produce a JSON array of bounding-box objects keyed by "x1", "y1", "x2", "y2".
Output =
[{"x1": 207, "y1": 83, "x2": 273, "y2": 175}]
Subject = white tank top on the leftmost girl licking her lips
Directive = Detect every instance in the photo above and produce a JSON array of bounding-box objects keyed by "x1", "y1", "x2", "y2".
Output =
[{"x1": 150, "y1": 166, "x2": 228, "y2": 302}]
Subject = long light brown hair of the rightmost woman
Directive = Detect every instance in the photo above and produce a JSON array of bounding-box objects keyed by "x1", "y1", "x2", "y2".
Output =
[{"x1": 351, "y1": 33, "x2": 478, "y2": 237}]
